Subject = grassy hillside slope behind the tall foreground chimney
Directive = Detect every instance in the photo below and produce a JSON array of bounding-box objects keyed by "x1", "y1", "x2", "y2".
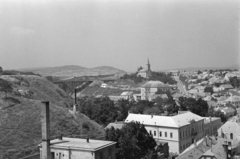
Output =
[{"x1": 0, "y1": 75, "x2": 104, "y2": 159}]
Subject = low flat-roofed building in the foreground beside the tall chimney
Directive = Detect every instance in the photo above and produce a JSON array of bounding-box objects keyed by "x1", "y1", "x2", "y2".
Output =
[{"x1": 39, "y1": 137, "x2": 116, "y2": 159}]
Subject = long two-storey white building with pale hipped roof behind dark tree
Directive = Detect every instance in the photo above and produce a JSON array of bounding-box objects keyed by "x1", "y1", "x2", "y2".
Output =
[{"x1": 125, "y1": 112, "x2": 204, "y2": 154}]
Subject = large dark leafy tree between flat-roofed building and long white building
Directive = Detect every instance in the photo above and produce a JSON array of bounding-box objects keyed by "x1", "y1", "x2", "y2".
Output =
[{"x1": 106, "y1": 122, "x2": 156, "y2": 159}]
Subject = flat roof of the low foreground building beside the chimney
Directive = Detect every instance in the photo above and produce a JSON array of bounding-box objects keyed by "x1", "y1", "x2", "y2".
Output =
[{"x1": 39, "y1": 137, "x2": 116, "y2": 151}]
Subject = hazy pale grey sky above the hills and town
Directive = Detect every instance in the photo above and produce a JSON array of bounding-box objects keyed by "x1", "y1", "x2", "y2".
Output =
[{"x1": 0, "y1": 0, "x2": 240, "y2": 71}]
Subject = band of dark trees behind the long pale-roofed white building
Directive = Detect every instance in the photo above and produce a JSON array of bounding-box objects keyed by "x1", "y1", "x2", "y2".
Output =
[{"x1": 77, "y1": 96, "x2": 214, "y2": 126}]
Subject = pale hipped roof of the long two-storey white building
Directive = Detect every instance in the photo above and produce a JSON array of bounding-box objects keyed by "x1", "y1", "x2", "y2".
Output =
[{"x1": 125, "y1": 112, "x2": 204, "y2": 128}]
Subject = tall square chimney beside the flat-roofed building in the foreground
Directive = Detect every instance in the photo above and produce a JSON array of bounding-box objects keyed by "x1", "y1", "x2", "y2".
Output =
[{"x1": 41, "y1": 101, "x2": 51, "y2": 159}]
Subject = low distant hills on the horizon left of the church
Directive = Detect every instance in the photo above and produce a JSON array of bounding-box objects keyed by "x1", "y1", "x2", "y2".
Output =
[{"x1": 18, "y1": 65, "x2": 126, "y2": 76}]
